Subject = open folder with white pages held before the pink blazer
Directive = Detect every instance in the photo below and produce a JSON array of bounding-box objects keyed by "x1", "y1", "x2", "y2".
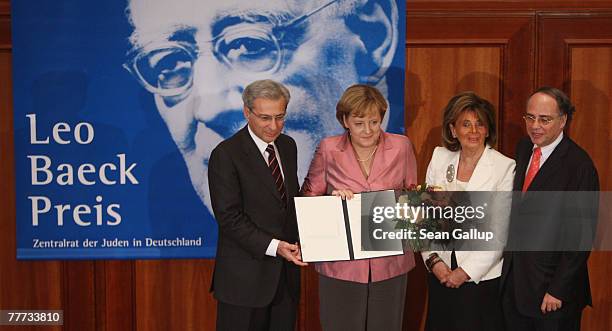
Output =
[{"x1": 295, "y1": 191, "x2": 404, "y2": 262}]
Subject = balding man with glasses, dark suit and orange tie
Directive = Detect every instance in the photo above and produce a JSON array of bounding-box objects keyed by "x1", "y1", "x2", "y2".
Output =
[{"x1": 501, "y1": 87, "x2": 599, "y2": 331}]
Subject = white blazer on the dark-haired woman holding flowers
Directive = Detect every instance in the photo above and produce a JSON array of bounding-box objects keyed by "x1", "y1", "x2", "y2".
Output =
[{"x1": 421, "y1": 145, "x2": 516, "y2": 283}]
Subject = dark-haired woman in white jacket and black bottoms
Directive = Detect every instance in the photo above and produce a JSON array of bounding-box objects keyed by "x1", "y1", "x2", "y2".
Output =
[{"x1": 421, "y1": 92, "x2": 515, "y2": 331}]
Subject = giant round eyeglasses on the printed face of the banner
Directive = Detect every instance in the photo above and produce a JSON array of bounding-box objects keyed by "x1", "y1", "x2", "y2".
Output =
[{"x1": 123, "y1": 0, "x2": 340, "y2": 97}]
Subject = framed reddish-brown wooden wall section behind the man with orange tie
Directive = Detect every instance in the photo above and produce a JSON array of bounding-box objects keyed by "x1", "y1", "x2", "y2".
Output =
[{"x1": 537, "y1": 12, "x2": 612, "y2": 330}]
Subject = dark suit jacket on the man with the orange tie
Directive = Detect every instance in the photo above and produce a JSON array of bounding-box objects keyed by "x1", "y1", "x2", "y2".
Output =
[{"x1": 501, "y1": 136, "x2": 599, "y2": 318}]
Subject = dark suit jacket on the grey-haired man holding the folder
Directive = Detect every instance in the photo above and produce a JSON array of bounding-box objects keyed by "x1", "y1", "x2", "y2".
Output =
[{"x1": 208, "y1": 127, "x2": 300, "y2": 307}]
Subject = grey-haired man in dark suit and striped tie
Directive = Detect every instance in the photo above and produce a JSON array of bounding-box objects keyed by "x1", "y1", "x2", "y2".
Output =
[{"x1": 208, "y1": 80, "x2": 305, "y2": 330}]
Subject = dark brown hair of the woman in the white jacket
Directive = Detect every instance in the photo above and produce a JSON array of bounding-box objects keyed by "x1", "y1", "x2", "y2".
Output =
[{"x1": 442, "y1": 91, "x2": 497, "y2": 151}]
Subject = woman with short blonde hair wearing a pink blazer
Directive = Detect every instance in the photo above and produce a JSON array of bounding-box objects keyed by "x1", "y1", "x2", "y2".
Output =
[{"x1": 302, "y1": 85, "x2": 416, "y2": 330}]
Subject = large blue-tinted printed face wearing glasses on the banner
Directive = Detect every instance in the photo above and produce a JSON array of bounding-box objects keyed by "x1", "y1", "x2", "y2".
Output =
[{"x1": 125, "y1": 0, "x2": 403, "y2": 215}]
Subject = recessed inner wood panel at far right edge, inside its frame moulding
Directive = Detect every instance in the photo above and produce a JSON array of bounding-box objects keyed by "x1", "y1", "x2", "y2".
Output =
[{"x1": 568, "y1": 45, "x2": 612, "y2": 330}]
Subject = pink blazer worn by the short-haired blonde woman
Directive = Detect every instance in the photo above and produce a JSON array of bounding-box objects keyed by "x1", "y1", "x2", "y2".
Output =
[{"x1": 302, "y1": 132, "x2": 416, "y2": 283}]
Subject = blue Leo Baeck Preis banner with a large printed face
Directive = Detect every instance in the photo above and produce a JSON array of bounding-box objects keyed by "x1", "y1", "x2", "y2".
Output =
[{"x1": 11, "y1": 0, "x2": 405, "y2": 259}]
